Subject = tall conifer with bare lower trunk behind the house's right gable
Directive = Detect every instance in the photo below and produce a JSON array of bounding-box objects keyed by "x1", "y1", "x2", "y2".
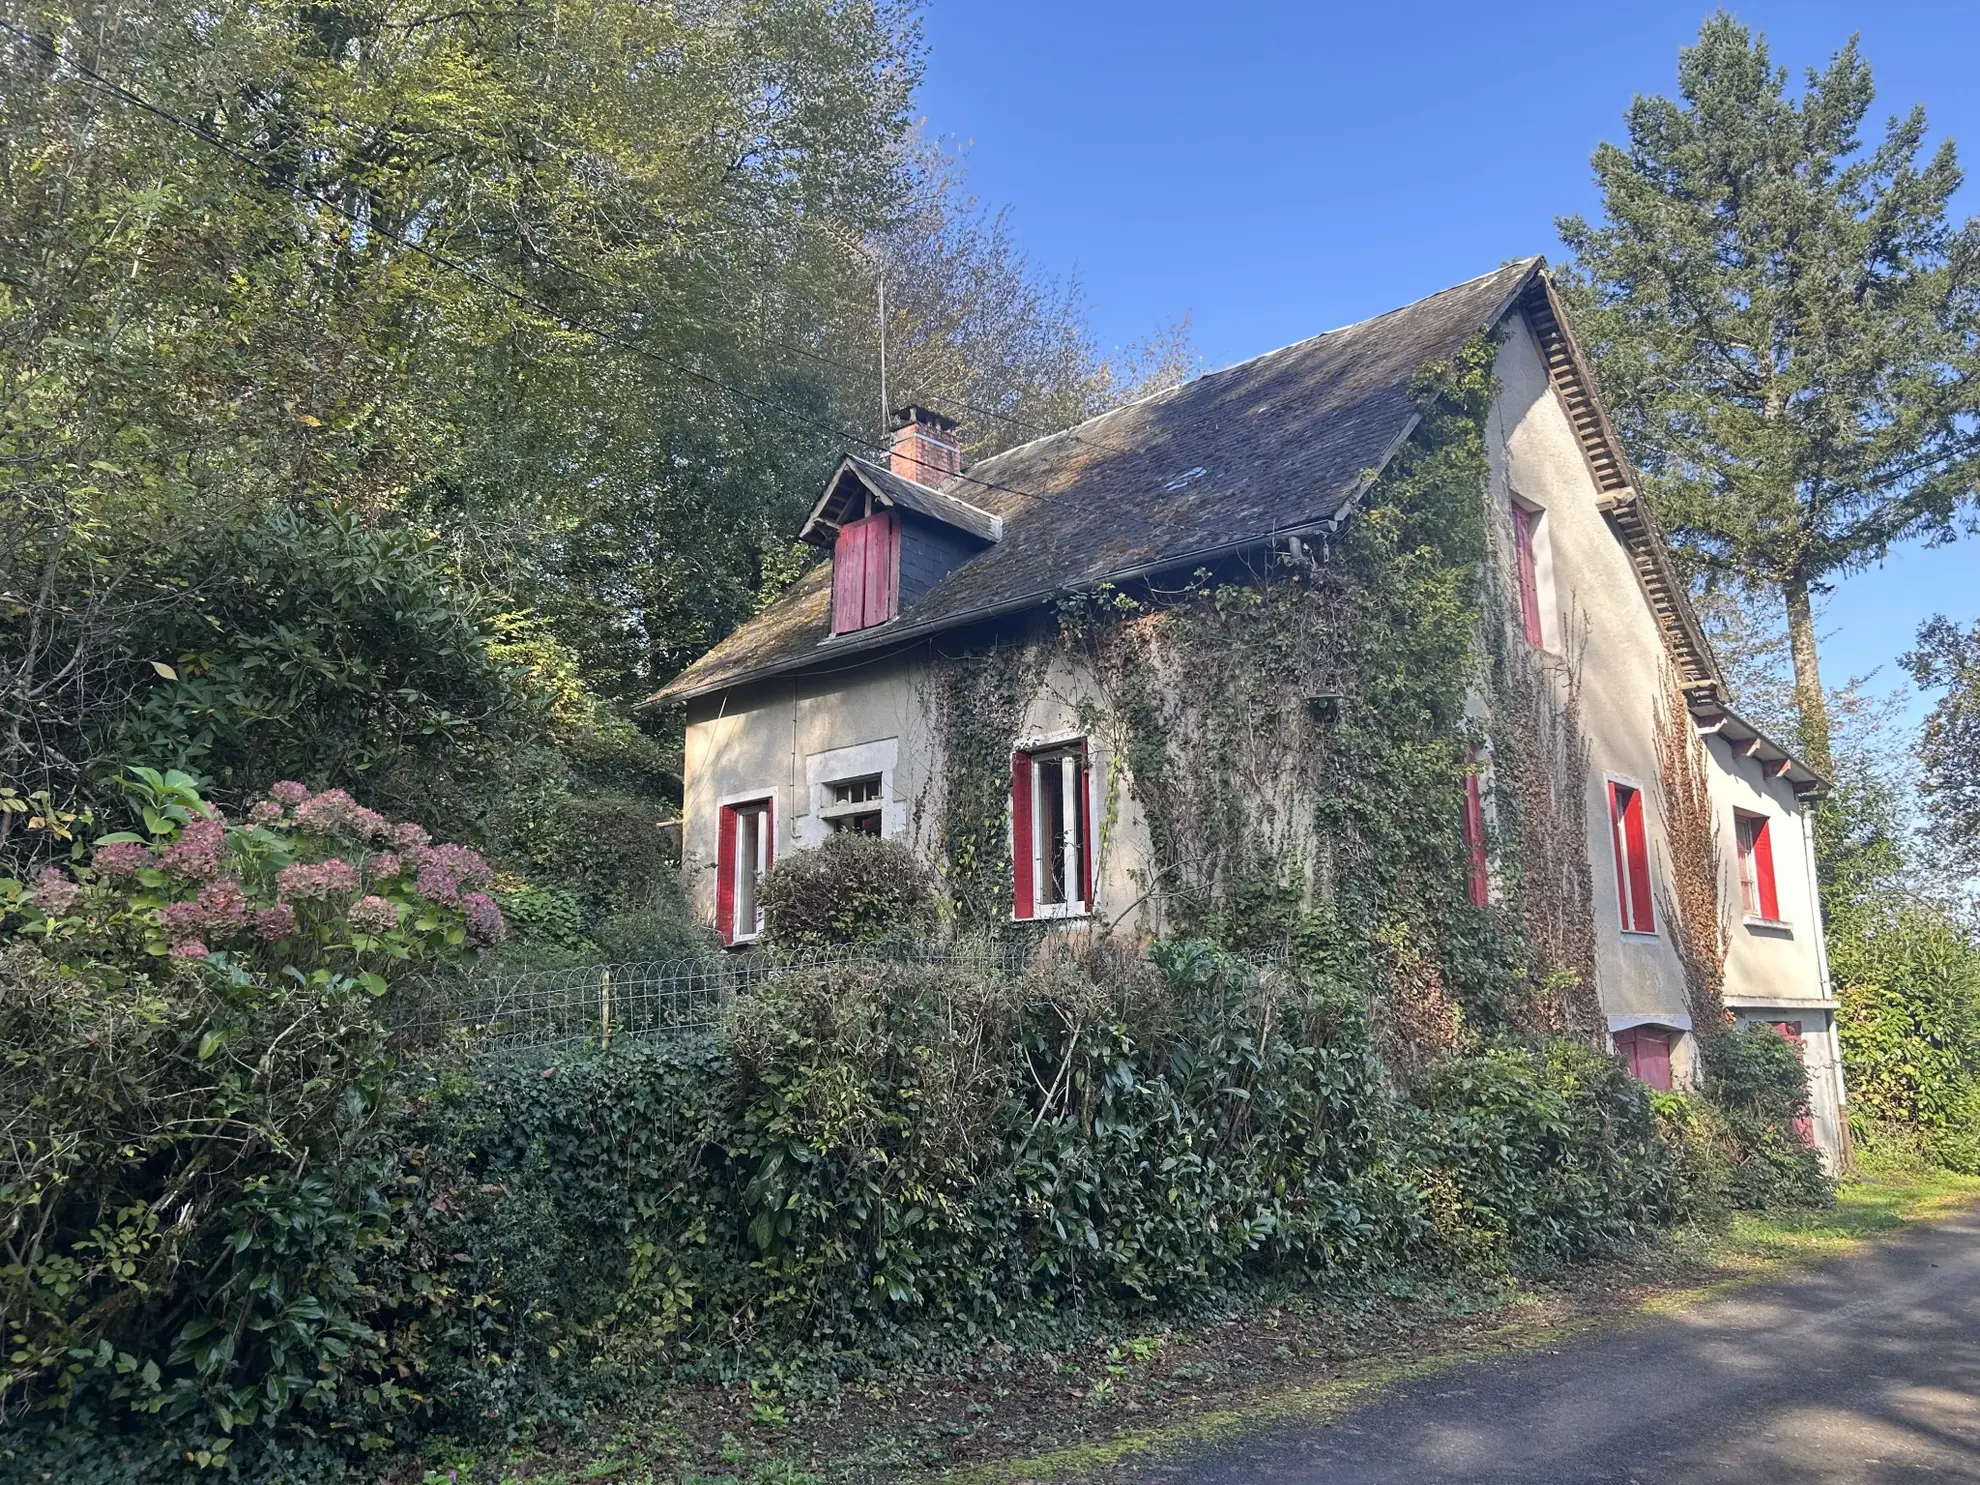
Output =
[{"x1": 1558, "y1": 12, "x2": 1980, "y2": 768}]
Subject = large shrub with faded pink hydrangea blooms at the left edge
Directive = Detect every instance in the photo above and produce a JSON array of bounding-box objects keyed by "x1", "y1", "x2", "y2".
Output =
[{"x1": 0, "y1": 770, "x2": 503, "y2": 1459}]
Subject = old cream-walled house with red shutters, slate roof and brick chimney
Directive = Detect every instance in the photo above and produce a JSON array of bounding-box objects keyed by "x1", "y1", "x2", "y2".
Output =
[{"x1": 655, "y1": 257, "x2": 1843, "y2": 1154}]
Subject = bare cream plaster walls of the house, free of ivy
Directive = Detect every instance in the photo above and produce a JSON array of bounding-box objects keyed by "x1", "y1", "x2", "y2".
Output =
[{"x1": 683, "y1": 297, "x2": 1843, "y2": 1154}]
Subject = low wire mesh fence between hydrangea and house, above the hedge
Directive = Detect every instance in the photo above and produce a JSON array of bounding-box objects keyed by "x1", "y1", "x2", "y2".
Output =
[{"x1": 392, "y1": 941, "x2": 1034, "y2": 1051}]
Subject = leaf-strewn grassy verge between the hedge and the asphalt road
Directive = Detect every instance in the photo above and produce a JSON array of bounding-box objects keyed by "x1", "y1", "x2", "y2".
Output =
[{"x1": 412, "y1": 1162, "x2": 1980, "y2": 1485}]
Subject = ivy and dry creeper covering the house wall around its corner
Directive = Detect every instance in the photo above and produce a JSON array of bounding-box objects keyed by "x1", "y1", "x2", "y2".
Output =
[{"x1": 939, "y1": 335, "x2": 1600, "y2": 1071}]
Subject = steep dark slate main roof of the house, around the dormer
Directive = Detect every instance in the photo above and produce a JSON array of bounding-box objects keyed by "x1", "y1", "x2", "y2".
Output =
[{"x1": 651, "y1": 257, "x2": 1544, "y2": 701}]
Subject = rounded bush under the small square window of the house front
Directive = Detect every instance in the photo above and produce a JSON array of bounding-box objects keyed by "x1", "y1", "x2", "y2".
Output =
[{"x1": 760, "y1": 830, "x2": 935, "y2": 944}]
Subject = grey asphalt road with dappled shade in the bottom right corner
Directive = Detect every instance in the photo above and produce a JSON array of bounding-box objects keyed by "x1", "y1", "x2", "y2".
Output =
[{"x1": 1140, "y1": 1214, "x2": 1980, "y2": 1485}]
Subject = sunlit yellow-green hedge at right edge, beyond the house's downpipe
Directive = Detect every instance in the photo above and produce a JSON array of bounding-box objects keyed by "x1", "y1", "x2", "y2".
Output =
[{"x1": 1832, "y1": 903, "x2": 1980, "y2": 1174}]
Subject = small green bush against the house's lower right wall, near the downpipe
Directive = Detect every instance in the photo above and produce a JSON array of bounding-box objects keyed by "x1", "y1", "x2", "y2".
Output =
[{"x1": 1699, "y1": 1026, "x2": 1835, "y2": 1212}]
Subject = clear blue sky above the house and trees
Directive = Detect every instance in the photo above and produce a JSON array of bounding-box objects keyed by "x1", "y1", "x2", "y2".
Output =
[{"x1": 921, "y1": 0, "x2": 1980, "y2": 709}]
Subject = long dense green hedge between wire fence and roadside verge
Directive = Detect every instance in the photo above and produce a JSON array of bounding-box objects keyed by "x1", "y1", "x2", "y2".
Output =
[{"x1": 382, "y1": 942, "x2": 1683, "y2": 1428}]
